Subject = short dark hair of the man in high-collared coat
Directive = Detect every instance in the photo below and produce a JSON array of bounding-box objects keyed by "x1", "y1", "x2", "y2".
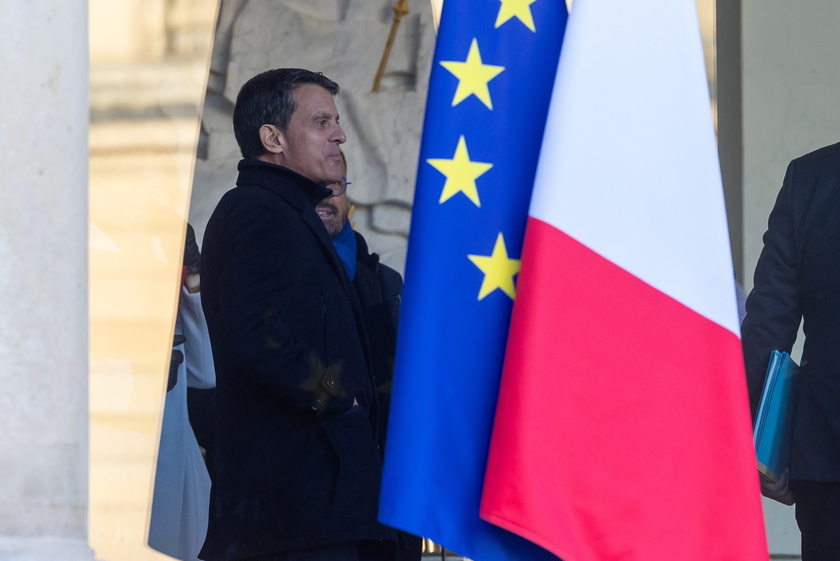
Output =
[{"x1": 233, "y1": 68, "x2": 339, "y2": 158}]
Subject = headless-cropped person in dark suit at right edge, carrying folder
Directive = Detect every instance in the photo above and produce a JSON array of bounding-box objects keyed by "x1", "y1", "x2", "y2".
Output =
[{"x1": 741, "y1": 144, "x2": 840, "y2": 561}]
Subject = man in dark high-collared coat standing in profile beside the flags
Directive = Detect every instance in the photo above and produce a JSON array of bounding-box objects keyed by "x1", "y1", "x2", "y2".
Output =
[{"x1": 199, "y1": 69, "x2": 396, "y2": 561}]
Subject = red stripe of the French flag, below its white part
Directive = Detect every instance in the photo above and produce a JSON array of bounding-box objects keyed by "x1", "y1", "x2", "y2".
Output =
[{"x1": 482, "y1": 218, "x2": 767, "y2": 561}]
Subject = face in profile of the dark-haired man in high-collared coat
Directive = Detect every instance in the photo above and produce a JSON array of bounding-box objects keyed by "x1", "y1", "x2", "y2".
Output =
[{"x1": 279, "y1": 84, "x2": 346, "y2": 185}]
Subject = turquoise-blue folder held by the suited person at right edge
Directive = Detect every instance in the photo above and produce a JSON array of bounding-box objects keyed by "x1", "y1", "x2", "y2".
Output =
[{"x1": 753, "y1": 351, "x2": 799, "y2": 481}]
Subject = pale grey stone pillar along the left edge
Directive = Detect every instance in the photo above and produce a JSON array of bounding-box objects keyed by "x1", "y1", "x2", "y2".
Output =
[{"x1": 0, "y1": 0, "x2": 93, "y2": 561}]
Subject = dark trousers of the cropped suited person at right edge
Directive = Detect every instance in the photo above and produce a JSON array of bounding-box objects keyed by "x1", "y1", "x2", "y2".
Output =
[{"x1": 790, "y1": 480, "x2": 840, "y2": 561}]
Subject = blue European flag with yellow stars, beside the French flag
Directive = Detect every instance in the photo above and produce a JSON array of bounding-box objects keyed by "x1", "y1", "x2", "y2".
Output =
[{"x1": 380, "y1": 0, "x2": 567, "y2": 561}]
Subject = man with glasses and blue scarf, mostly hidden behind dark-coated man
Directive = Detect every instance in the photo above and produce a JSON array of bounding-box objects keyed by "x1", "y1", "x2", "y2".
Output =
[{"x1": 315, "y1": 152, "x2": 422, "y2": 561}]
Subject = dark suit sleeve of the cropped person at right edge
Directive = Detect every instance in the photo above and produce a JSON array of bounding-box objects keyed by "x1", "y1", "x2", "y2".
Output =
[{"x1": 741, "y1": 162, "x2": 802, "y2": 418}]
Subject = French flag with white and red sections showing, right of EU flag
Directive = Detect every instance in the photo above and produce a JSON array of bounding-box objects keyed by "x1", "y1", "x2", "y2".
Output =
[{"x1": 481, "y1": 0, "x2": 768, "y2": 561}]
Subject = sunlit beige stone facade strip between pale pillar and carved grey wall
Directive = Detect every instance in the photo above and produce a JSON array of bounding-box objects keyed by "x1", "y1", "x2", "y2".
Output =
[{"x1": 88, "y1": 0, "x2": 217, "y2": 561}]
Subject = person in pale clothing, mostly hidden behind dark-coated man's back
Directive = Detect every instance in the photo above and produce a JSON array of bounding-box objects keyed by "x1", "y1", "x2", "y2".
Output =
[{"x1": 148, "y1": 226, "x2": 216, "y2": 561}]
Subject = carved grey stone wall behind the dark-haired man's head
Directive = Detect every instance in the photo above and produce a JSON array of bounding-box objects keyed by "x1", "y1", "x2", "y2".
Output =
[{"x1": 190, "y1": 0, "x2": 434, "y2": 271}]
